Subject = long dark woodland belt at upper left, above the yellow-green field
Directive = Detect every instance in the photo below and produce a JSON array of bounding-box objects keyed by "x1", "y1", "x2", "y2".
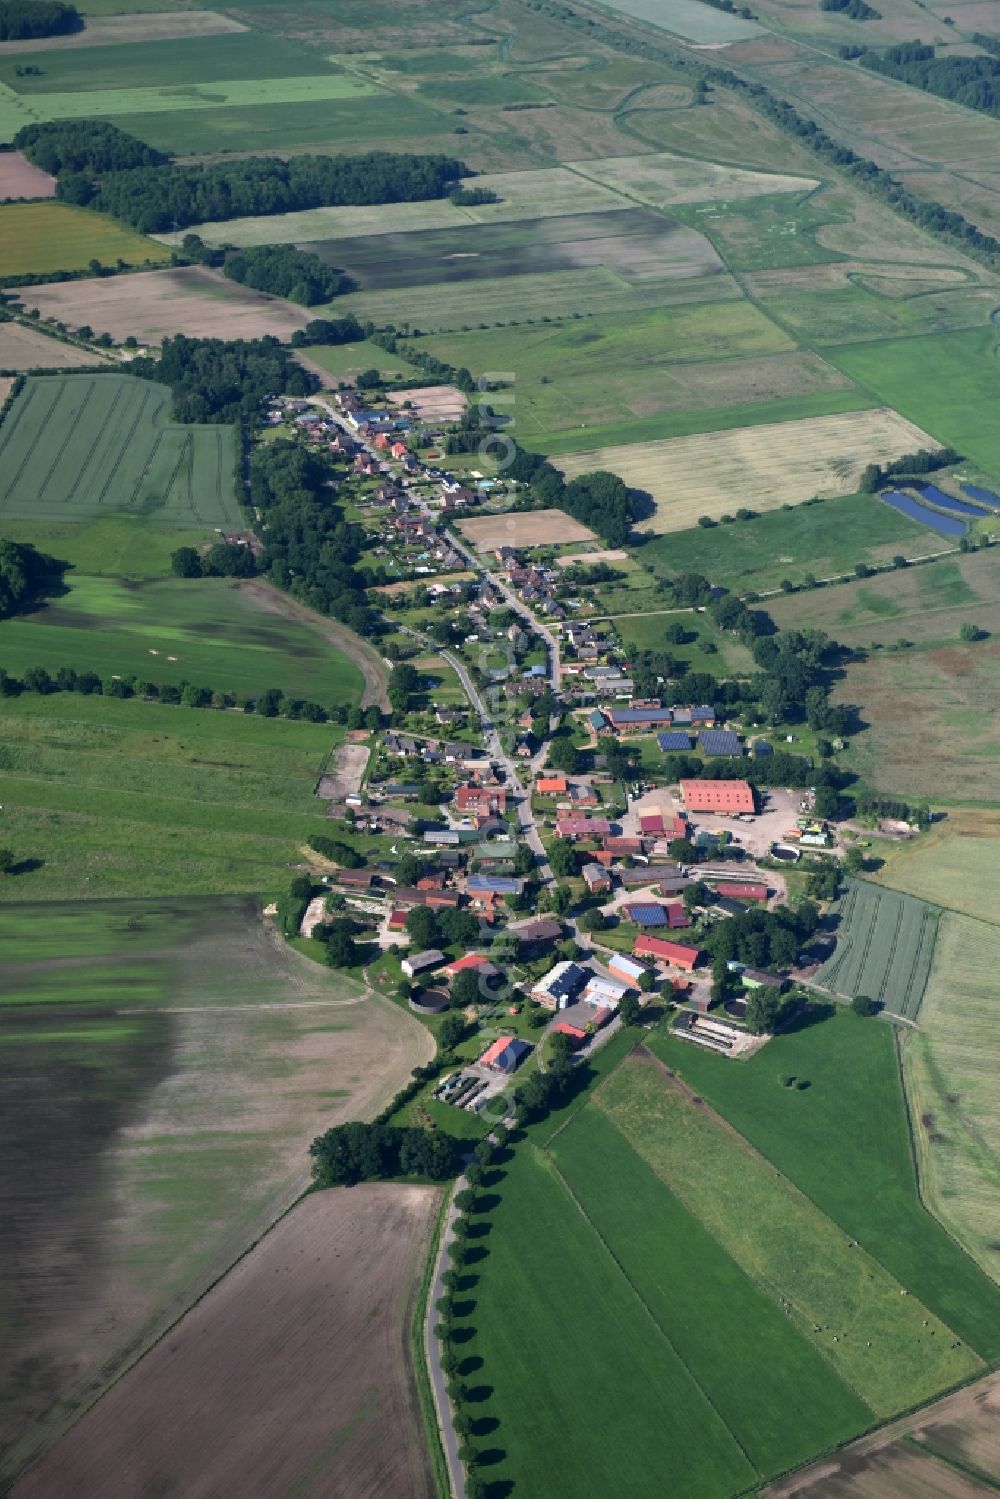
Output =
[{"x1": 13, "y1": 122, "x2": 469, "y2": 234}]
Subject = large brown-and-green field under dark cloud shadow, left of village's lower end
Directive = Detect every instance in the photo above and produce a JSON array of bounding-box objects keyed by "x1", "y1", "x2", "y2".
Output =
[{"x1": 0, "y1": 898, "x2": 429, "y2": 1493}]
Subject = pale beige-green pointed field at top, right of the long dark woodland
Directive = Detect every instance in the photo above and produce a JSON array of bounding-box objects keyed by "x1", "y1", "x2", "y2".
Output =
[{"x1": 576, "y1": 150, "x2": 819, "y2": 208}]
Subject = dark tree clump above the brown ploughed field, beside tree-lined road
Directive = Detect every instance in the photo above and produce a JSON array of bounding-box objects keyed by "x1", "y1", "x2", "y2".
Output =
[{"x1": 309, "y1": 1121, "x2": 462, "y2": 1187}]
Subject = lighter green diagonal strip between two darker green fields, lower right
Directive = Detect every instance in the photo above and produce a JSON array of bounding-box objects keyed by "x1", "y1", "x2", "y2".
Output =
[{"x1": 595, "y1": 1055, "x2": 982, "y2": 1417}]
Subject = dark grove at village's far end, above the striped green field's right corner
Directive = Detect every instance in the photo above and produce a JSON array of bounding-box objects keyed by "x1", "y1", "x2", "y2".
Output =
[{"x1": 126, "y1": 333, "x2": 319, "y2": 423}]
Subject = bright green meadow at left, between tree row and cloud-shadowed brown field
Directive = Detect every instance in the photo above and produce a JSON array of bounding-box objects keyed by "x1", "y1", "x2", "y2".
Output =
[{"x1": 0, "y1": 693, "x2": 367, "y2": 902}]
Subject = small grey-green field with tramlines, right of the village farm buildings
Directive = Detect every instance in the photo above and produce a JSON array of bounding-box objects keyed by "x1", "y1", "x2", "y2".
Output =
[{"x1": 816, "y1": 880, "x2": 937, "y2": 1021}]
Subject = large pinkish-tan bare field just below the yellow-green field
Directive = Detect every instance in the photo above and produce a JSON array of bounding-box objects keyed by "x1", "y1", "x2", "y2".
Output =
[{"x1": 18, "y1": 266, "x2": 312, "y2": 343}]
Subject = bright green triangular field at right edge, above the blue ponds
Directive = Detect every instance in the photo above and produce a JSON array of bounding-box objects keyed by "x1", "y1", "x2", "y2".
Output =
[{"x1": 826, "y1": 327, "x2": 1000, "y2": 480}]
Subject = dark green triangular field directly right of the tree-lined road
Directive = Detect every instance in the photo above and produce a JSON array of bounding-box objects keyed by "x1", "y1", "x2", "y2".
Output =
[{"x1": 440, "y1": 1145, "x2": 753, "y2": 1499}]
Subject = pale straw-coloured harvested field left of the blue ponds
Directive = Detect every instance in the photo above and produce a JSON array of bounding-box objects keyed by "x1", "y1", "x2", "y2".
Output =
[{"x1": 561, "y1": 406, "x2": 937, "y2": 535}]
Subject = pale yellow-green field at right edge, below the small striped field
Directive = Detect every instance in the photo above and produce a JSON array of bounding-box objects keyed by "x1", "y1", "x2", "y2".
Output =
[{"x1": 903, "y1": 911, "x2": 1000, "y2": 1280}]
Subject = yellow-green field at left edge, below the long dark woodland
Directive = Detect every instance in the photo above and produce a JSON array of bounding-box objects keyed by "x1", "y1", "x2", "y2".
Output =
[{"x1": 0, "y1": 200, "x2": 169, "y2": 276}]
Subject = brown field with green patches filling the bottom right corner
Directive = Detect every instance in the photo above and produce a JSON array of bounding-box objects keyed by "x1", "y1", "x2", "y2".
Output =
[{"x1": 762, "y1": 1373, "x2": 1000, "y2": 1499}]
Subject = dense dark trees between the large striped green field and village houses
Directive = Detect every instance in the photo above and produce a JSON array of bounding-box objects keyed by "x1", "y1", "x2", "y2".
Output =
[{"x1": 250, "y1": 439, "x2": 381, "y2": 637}]
